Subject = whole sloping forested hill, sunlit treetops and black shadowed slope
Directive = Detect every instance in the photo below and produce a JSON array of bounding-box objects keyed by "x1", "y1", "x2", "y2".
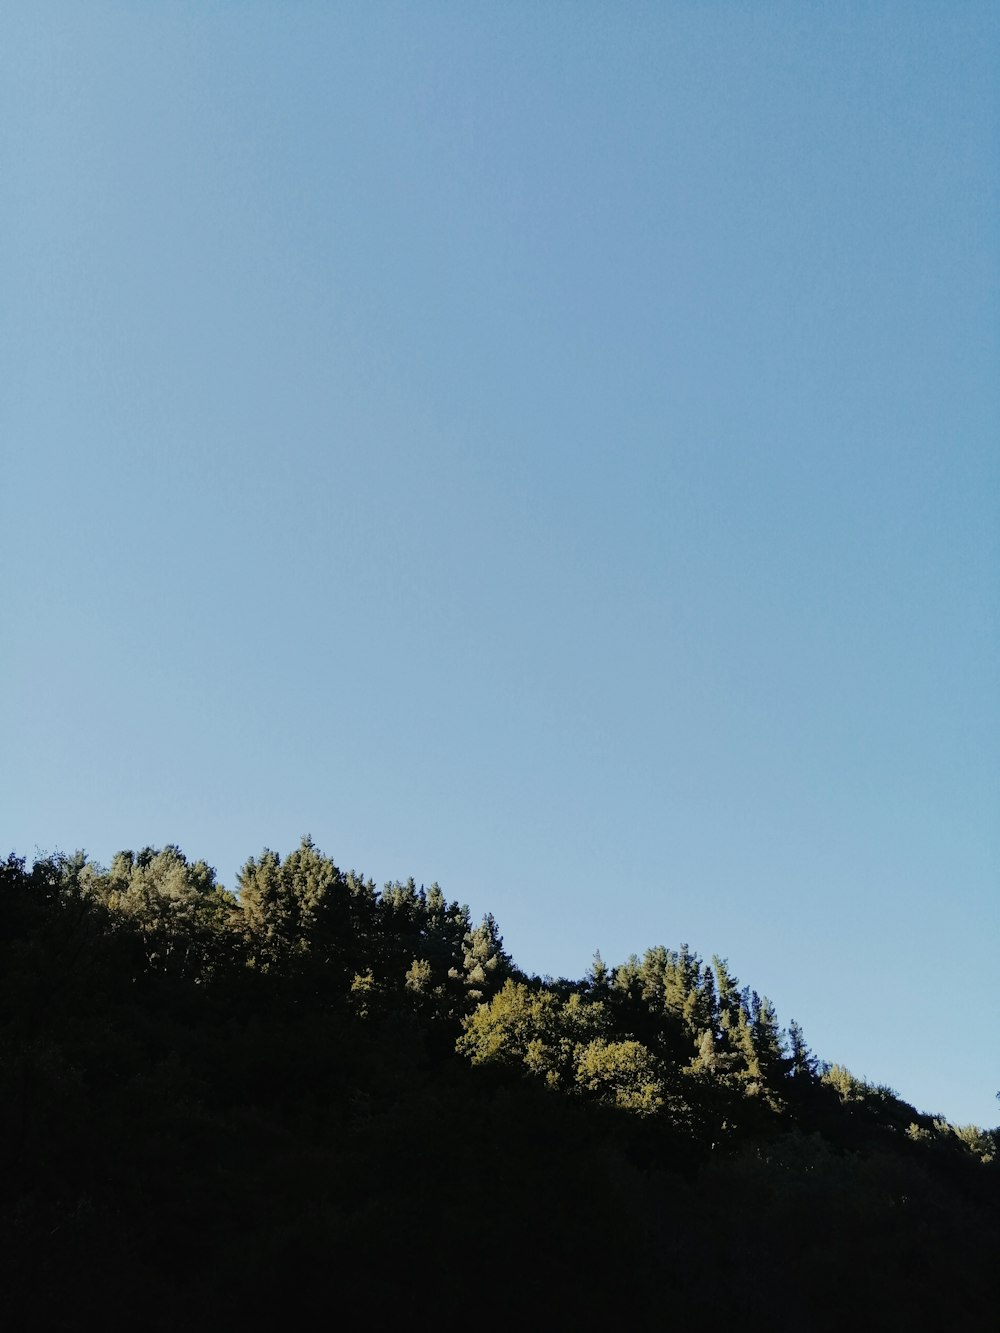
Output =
[{"x1": 0, "y1": 838, "x2": 1000, "y2": 1330}]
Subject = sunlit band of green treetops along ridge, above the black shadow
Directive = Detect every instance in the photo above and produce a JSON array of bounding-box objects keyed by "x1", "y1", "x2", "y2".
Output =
[{"x1": 0, "y1": 836, "x2": 1000, "y2": 1146}]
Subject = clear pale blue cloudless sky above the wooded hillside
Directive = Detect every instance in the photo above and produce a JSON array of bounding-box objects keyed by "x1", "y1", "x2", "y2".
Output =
[{"x1": 0, "y1": 0, "x2": 1000, "y2": 1125}]
